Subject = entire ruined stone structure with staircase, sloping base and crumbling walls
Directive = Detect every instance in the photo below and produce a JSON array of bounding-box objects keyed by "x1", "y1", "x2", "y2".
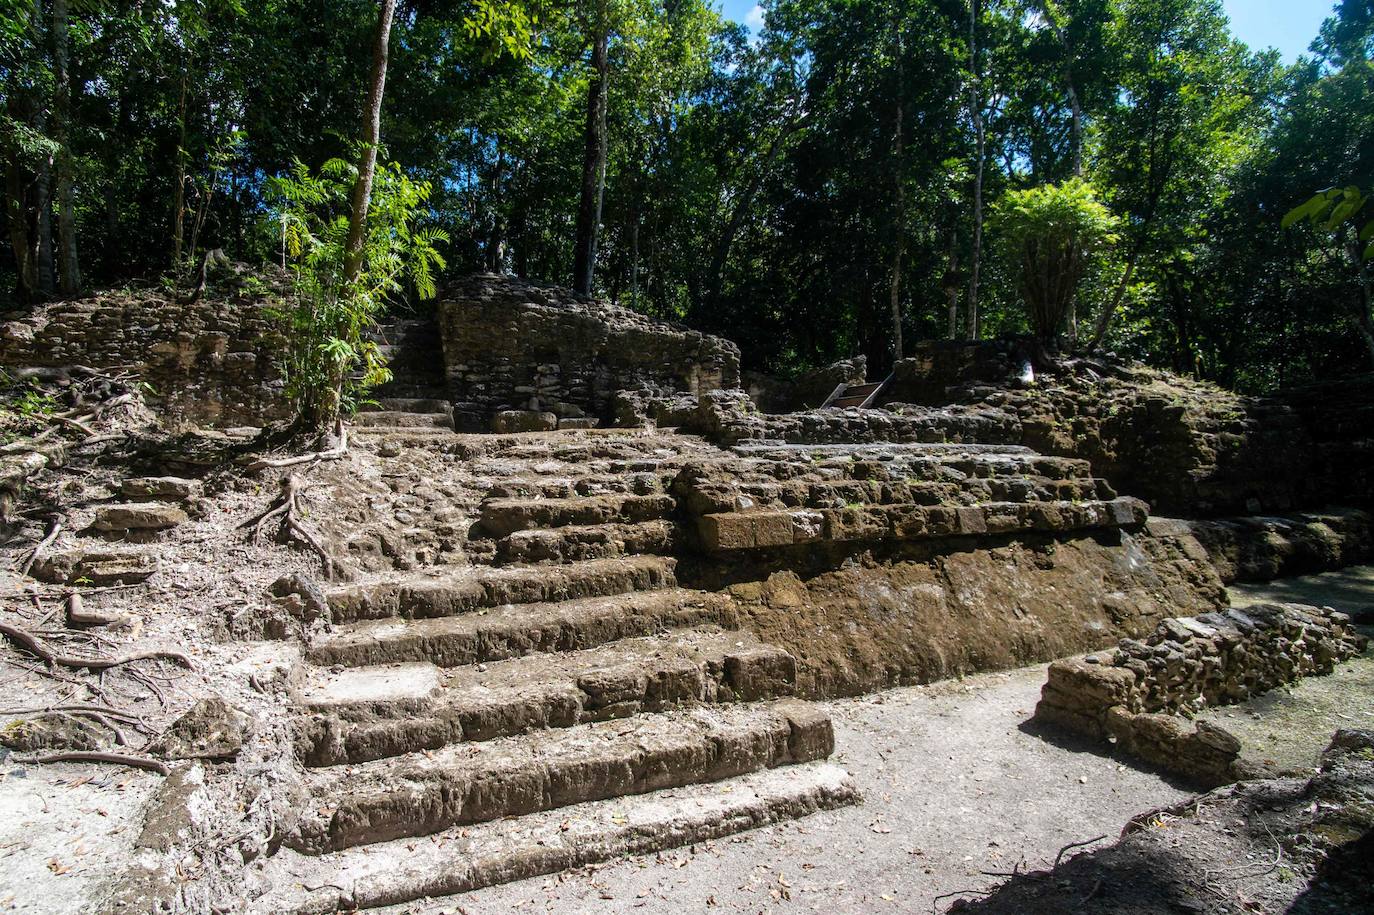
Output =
[{"x1": 7, "y1": 276, "x2": 1370, "y2": 912}]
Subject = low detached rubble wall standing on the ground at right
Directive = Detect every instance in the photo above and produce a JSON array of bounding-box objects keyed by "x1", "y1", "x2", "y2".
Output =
[{"x1": 1035, "y1": 603, "x2": 1367, "y2": 784}]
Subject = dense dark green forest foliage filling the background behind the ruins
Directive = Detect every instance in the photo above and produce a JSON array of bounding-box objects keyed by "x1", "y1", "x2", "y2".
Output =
[{"x1": 8, "y1": 0, "x2": 1374, "y2": 387}]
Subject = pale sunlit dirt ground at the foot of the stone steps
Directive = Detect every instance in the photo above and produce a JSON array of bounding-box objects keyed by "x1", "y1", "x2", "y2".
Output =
[{"x1": 387, "y1": 566, "x2": 1374, "y2": 915}]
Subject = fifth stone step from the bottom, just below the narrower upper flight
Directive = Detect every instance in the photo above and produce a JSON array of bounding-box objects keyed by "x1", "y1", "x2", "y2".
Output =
[{"x1": 327, "y1": 556, "x2": 677, "y2": 622}]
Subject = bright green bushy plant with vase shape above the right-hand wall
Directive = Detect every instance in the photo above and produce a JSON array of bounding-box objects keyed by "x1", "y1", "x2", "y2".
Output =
[{"x1": 991, "y1": 179, "x2": 1121, "y2": 339}]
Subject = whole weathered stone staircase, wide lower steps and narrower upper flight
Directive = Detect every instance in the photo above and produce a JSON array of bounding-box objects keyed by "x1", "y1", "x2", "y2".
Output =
[{"x1": 254, "y1": 428, "x2": 857, "y2": 912}]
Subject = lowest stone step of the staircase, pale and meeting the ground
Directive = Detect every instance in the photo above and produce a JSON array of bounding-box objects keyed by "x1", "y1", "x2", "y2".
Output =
[{"x1": 249, "y1": 763, "x2": 860, "y2": 915}]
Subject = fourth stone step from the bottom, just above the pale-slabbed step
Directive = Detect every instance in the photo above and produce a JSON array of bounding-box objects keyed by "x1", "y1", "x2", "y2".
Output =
[{"x1": 305, "y1": 588, "x2": 731, "y2": 668}]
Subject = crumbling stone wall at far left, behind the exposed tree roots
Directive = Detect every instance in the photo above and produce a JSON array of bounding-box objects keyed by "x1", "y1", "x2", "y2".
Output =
[{"x1": 0, "y1": 289, "x2": 287, "y2": 426}]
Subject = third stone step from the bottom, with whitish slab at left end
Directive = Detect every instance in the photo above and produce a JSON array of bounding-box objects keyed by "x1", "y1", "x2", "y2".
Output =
[{"x1": 294, "y1": 629, "x2": 797, "y2": 767}]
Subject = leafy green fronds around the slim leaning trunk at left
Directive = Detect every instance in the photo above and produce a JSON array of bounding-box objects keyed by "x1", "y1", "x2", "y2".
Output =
[{"x1": 268, "y1": 159, "x2": 448, "y2": 429}]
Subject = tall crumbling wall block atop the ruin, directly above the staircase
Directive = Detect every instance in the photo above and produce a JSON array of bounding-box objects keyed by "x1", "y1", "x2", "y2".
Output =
[{"x1": 438, "y1": 275, "x2": 739, "y2": 420}]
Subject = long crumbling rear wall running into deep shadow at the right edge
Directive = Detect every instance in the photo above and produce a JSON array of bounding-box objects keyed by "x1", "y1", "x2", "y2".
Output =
[{"x1": 694, "y1": 343, "x2": 1374, "y2": 518}]
